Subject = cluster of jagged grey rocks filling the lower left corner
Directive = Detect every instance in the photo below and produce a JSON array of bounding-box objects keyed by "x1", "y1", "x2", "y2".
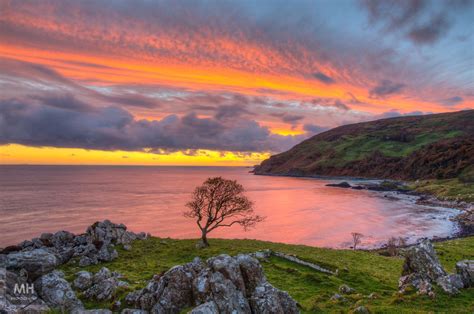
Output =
[{"x1": 0, "y1": 220, "x2": 147, "y2": 313}]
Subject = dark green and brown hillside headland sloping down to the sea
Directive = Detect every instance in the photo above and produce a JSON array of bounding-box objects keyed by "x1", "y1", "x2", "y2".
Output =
[{"x1": 255, "y1": 110, "x2": 474, "y2": 183}]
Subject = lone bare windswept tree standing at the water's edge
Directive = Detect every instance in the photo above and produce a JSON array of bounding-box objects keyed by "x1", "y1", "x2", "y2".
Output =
[{"x1": 184, "y1": 177, "x2": 265, "y2": 247}]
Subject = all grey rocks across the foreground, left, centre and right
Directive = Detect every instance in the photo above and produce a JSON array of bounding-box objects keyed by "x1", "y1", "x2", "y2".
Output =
[{"x1": 0, "y1": 221, "x2": 474, "y2": 313}]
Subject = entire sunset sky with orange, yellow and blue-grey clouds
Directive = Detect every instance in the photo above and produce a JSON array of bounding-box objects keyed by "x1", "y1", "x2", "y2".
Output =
[{"x1": 0, "y1": 0, "x2": 474, "y2": 166}]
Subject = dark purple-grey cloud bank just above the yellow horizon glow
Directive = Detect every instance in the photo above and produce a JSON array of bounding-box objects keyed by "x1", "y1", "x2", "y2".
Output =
[{"x1": 0, "y1": 98, "x2": 301, "y2": 152}]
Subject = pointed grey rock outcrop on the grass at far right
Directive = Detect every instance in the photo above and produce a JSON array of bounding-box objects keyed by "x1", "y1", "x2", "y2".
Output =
[{"x1": 399, "y1": 240, "x2": 463, "y2": 294}]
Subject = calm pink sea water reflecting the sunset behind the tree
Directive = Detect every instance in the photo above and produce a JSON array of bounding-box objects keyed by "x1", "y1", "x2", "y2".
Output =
[{"x1": 0, "y1": 166, "x2": 457, "y2": 247}]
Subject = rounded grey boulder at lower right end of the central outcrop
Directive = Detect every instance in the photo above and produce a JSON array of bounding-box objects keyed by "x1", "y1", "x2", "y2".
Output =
[{"x1": 250, "y1": 283, "x2": 299, "y2": 314}]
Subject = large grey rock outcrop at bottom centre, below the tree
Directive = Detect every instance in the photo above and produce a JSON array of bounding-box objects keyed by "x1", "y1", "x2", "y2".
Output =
[{"x1": 126, "y1": 255, "x2": 299, "y2": 313}]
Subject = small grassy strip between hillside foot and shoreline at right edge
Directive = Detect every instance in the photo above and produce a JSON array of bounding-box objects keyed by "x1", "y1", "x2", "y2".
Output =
[{"x1": 410, "y1": 178, "x2": 474, "y2": 203}]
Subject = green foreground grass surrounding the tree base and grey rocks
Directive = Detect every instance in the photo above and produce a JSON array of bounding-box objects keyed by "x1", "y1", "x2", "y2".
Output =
[{"x1": 62, "y1": 237, "x2": 474, "y2": 313}]
